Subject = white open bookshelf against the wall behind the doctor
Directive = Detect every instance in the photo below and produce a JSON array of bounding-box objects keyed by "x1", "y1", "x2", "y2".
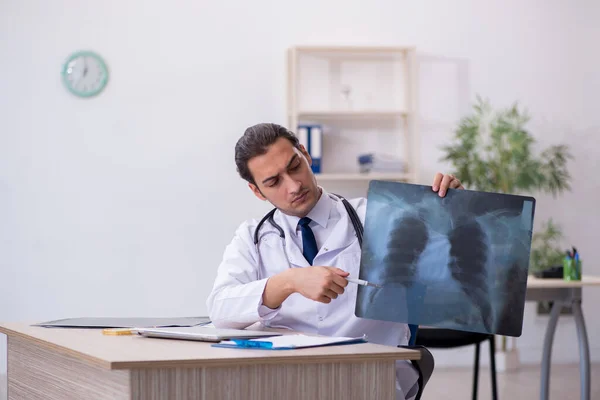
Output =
[{"x1": 287, "y1": 46, "x2": 419, "y2": 182}]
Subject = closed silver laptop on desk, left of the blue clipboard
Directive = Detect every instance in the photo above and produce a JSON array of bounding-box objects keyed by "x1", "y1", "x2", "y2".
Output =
[{"x1": 135, "y1": 326, "x2": 281, "y2": 342}]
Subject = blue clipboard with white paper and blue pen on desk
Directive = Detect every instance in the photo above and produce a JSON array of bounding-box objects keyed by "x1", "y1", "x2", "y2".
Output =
[{"x1": 213, "y1": 334, "x2": 367, "y2": 350}]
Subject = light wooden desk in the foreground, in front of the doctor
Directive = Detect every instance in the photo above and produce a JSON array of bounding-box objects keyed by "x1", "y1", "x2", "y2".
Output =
[{"x1": 0, "y1": 323, "x2": 419, "y2": 400}]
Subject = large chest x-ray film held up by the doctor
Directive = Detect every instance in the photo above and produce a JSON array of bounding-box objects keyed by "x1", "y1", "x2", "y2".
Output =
[{"x1": 355, "y1": 181, "x2": 535, "y2": 336}]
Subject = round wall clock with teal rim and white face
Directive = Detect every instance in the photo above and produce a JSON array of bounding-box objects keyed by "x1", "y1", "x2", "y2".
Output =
[{"x1": 62, "y1": 51, "x2": 108, "y2": 97}]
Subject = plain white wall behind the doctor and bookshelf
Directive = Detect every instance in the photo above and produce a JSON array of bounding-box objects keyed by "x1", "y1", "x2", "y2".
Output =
[{"x1": 0, "y1": 0, "x2": 600, "y2": 376}]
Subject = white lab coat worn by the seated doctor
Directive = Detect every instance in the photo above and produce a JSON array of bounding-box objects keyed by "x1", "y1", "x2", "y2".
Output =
[{"x1": 207, "y1": 191, "x2": 418, "y2": 400}]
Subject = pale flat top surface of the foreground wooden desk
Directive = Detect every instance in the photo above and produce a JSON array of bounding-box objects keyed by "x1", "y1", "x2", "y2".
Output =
[{"x1": 0, "y1": 323, "x2": 419, "y2": 369}]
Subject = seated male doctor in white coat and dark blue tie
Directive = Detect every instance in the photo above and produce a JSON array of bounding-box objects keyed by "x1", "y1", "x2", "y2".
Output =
[{"x1": 207, "y1": 123, "x2": 463, "y2": 400}]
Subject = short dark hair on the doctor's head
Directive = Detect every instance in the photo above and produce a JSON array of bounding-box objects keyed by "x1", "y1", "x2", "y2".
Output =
[{"x1": 235, "y1": 123, "x2": 300, "y2": 184}]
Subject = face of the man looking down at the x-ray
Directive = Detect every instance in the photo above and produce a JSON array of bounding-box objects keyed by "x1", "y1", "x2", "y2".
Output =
[{"x1": 248, "y1": 138, "x2": 320, "y2": 218}]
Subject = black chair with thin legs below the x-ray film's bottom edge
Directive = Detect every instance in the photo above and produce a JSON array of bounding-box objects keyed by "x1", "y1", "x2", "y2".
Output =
[{"x1": 415, "y1": 328, "x2": 498, "y2": 400}]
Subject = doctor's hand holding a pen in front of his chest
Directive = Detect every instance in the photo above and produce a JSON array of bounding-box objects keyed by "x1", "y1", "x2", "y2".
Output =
[{"x1": 289, "y1": 267, "x2": 349, "y2": 303}]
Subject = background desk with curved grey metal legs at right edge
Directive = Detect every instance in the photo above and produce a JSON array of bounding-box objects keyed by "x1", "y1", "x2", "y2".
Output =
[{"x1": 526, "y1": 275, "x2": 600, "y2": 400}]
